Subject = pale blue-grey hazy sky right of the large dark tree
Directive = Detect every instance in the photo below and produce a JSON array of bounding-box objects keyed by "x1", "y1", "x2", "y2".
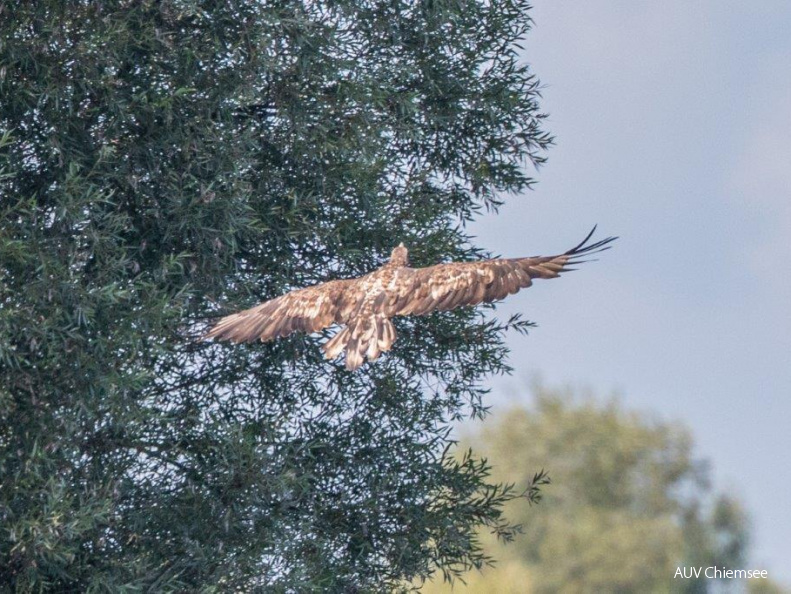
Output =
[{"x1": 471, "y1": 0, "x2": 791, "y2": 584}]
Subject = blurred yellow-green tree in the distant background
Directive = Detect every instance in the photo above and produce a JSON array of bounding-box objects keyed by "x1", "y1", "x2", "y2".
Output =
[{"x1": 423, "y1": 386, "x2": 784, "y2": 593}]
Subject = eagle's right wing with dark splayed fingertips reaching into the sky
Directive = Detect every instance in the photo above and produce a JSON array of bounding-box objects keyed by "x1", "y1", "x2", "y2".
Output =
[{"x1": 386, "y1": 227, "x2": 616, "y2": 316}]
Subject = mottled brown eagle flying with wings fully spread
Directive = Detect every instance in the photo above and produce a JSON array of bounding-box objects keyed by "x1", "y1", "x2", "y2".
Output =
[{"x1": 204, "y1": 227, "x2": 616, "y2": 371}]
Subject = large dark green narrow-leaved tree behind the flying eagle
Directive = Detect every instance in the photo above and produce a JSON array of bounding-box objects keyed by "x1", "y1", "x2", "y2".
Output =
[{"x1": 0, "y1": 0, "x2": 551, "y2": 592}]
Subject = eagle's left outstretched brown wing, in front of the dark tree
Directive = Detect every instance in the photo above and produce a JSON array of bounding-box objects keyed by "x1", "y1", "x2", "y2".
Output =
[{"x1": 203, "y1": 279, "x2": 363, "y2": 342}]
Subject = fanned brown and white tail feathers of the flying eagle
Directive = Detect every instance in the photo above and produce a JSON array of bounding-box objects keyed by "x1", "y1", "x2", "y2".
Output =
[{"x1": 322, "y1": 316, "x2": 396, "y2": 371}]
